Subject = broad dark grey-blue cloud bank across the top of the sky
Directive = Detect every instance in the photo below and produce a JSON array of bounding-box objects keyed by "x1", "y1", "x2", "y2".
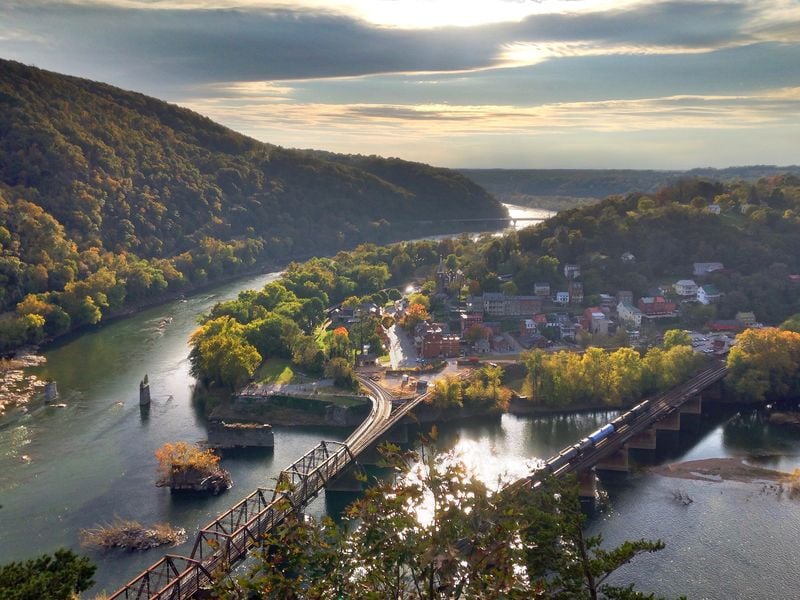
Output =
[{"x1": 0, "y1": 0, "x2": 800, "y2": 88}]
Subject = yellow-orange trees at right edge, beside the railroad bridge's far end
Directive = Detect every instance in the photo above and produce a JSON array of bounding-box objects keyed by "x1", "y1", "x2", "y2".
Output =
[{"x1": 726, "y1": 327, "x2": 800, "y2": 402}]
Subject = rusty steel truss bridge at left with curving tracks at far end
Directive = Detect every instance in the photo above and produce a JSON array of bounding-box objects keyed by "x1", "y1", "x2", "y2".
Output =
[{"x1": 108, "y1": 377, "x2": 427, "y2": 600}]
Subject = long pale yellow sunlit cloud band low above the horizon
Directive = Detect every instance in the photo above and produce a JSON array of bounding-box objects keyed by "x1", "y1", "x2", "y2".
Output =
[{"x1": 180, "y1": 88, "x2": 800, "y2": 143}]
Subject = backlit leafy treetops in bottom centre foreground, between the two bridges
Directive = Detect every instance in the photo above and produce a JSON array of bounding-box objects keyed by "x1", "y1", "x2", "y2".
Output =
[{"x1": 221, "y1": 438, "x2": 676, "y2": 600}]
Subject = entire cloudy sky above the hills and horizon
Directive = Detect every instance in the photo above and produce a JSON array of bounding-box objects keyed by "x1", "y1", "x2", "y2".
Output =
[{"x1": 0, "y1": 0, "x2": 800, "y2": 169}]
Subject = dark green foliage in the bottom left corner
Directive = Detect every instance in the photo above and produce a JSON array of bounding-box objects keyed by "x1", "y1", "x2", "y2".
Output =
[{"x1": 0, "y1": 548, "x2": 96, "y2": 600}]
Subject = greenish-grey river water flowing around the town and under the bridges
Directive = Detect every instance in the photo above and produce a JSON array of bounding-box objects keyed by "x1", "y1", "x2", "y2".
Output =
[{"x1": 0, "y1": 205, "x2": 800, "y2": 599}]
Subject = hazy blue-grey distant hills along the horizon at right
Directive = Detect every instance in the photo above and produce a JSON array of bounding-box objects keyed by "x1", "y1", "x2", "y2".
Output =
[{"x1": 459, "y1": 165, "x2": 800, "y2": 210}]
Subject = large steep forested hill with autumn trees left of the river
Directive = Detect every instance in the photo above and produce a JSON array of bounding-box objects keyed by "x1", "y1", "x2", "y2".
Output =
[{"x1": 0, "y1": 60, "x2": 504, "y2": 349}]
